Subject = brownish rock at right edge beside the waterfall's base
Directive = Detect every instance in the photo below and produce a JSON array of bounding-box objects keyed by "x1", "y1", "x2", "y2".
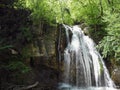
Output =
[{"x1": 112, "y1": 67, "x2": 120, "y2": 88}]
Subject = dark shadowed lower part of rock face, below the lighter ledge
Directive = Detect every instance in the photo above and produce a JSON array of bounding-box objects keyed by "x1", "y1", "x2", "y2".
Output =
[{"x1": 25, "y1": 57, "x2": 59, "y2": 90}]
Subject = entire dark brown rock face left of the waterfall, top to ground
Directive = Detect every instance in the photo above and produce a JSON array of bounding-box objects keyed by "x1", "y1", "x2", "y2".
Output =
[{"x1": 22, "y1": 25, "x2": 59, "y2": 90}]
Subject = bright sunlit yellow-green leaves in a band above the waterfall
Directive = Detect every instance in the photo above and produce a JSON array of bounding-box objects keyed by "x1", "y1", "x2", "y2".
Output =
[{"x1": 23, "y1": 0, "x2": 103, "y2": 24}]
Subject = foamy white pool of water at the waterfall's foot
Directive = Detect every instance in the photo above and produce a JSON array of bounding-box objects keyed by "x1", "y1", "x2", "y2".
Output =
[{"x1": 59, "y1": 83, "x2": 120, "y2": 90}]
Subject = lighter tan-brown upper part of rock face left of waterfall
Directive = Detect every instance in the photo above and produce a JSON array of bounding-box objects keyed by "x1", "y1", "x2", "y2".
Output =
[{"x1": 32, "y1": 25, "x2": 56, "y2": 57}]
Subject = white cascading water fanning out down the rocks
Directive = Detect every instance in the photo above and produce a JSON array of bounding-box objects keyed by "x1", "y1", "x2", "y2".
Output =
[{"x1": 59, "y1": 25, "x2": 115, "y2": 87}]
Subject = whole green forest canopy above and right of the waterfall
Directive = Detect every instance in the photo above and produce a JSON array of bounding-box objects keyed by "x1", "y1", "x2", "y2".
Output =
[{"x1": 22, "y1": 0, "x2": 120, "y2": 63}]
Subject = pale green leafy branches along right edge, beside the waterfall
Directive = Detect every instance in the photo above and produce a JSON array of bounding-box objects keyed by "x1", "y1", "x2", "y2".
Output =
[{"x1": 99, "y1": 10, "x2": 120, "y2": 64}]
